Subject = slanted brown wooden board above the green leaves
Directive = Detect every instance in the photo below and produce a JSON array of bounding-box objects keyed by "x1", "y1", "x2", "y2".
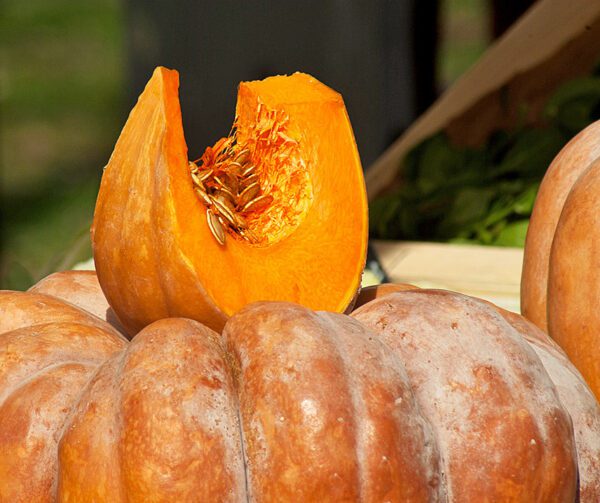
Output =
[{"x1": 366, "y1": 0, "x2": 600, "y2": 199}]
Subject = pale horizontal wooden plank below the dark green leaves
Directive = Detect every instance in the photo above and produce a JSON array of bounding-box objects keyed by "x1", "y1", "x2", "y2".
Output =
[{"x1": 372, "y1": 241, "x2": 523, "y2": 312}]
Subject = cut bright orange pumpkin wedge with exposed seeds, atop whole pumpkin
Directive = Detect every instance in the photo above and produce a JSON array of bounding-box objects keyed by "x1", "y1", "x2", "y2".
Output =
[{"x1": 92, "y1": 68, "x2": 368, "y2": 334}]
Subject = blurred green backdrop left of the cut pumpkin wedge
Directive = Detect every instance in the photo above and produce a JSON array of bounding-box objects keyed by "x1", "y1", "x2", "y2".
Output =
[{"x1": 0, "y1": 0, "x2": 125, "y2": 289}]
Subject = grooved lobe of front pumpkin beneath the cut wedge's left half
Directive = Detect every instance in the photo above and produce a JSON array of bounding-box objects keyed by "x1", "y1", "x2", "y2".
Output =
[{"x1": 57, "y1": 319, "x2": 245, "y2": 502}]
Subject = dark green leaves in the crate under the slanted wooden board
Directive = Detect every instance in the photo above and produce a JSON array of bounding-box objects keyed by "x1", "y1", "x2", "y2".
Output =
[{"x1": 370, "y1": 75, "x2": 600, "y2": 246}]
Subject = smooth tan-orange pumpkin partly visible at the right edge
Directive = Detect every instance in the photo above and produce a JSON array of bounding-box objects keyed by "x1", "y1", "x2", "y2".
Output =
[{"x1": 521, "y1": 121, "x2": 600, "y2": 398}]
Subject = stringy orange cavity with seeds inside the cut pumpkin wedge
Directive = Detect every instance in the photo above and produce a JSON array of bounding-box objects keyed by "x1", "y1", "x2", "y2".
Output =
[{"x1": 189, "y1": 101, "x2": 313, "y2": 246}]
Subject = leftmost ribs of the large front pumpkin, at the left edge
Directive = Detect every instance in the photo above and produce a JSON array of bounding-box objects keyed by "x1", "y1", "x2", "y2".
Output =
[{"x1": 0, "y1": 292, "x2": 125, "y2": 502}]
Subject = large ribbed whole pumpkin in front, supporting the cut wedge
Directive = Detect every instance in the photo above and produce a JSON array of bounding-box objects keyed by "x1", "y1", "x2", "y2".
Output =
[{"x1": 0, "y1": 273, "x2": 600, "y2": 502}]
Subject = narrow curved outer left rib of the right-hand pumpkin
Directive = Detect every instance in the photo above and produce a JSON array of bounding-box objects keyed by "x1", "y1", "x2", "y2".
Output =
[{"x1": 521, "y1": 121, "x2": 600, "y2": 331}]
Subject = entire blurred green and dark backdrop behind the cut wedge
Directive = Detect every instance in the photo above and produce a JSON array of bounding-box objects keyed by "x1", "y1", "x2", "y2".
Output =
[{"x1": 0, "y1": 0, "x2": 533, "y2": 289}]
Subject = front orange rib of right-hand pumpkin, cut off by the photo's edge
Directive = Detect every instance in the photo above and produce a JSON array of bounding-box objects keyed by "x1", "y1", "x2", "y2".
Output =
[{"x1": 548, "y1": 159, "x2": 600, "y2": 399}]
